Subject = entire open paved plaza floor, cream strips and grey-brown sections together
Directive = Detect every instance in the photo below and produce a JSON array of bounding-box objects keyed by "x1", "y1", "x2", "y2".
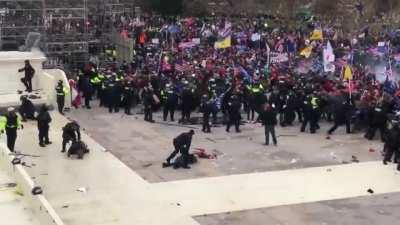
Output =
[{"x1": 1, "y1": 105, "x2": 400, "y2": 225}]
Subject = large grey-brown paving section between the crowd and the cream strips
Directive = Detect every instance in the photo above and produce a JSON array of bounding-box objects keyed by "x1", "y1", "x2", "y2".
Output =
[{"x1": 68, "y1": 102, "x2": 382, "y2": 182}]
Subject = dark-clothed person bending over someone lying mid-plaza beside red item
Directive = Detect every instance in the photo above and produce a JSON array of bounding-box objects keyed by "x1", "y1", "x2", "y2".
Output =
[{"x1": 163, "y1": 130, "x2": 194, "y2": 169}]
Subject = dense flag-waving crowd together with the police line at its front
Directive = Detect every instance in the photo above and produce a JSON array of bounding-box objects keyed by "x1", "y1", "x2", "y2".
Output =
[{"x1": 2, "y1": 14, "x2": 400, "y2": 169}]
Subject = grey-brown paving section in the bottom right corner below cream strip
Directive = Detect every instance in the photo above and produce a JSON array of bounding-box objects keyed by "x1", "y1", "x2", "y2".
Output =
[{"x1": 196, "y1": 194, "x2": 400, "y2": 225}]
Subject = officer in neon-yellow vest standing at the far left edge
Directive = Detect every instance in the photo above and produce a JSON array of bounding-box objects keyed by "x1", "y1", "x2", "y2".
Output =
[{"x1": 0, "y1": 107, "x2": 24, "y2": 152}]
